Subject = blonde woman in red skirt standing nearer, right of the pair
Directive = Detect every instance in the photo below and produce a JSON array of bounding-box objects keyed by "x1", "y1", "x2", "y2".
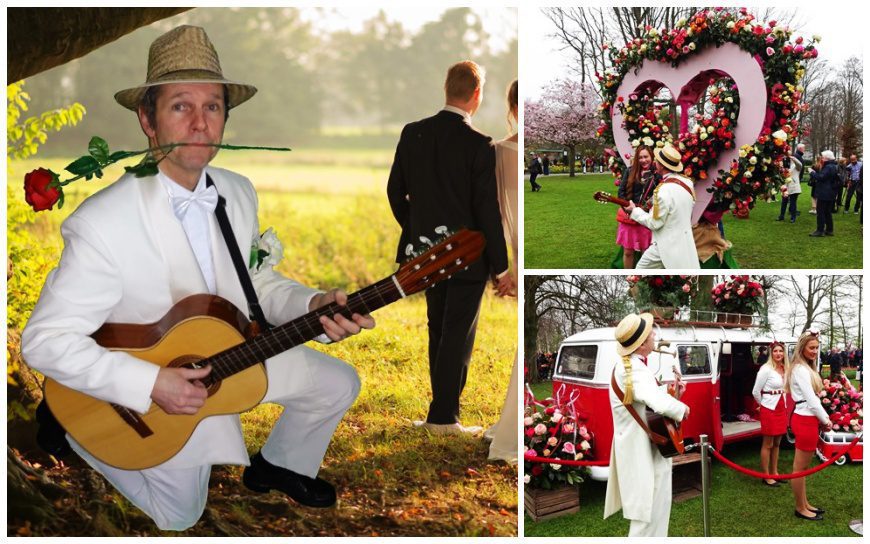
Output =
[{"x1": 785, "y1": 332, "x2": 831, "y2": 521}]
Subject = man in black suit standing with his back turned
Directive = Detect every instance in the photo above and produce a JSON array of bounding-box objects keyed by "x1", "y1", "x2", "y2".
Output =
[{"x1": 387, "y1": 61, "x2": 513, "y2": 434}]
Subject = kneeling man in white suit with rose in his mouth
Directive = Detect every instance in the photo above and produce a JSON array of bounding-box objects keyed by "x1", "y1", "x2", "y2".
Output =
[{"x1": 22, "y1": 26, "x2": 374, "y2": 530}]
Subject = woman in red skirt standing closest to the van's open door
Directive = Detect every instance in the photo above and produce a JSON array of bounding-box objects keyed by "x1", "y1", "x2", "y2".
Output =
[{"x1": 752, "y1": 342, "x2": 788, "y2": 487}]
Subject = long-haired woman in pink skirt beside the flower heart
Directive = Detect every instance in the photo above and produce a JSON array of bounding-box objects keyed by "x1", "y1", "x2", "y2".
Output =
[{"x1": 616, "y1": 145, "x2": 658, "y2": 269}]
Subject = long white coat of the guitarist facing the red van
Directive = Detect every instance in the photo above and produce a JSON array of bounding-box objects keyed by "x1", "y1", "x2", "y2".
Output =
[{"x1": 604, "y1": 354, "x2": 687, "y2": 523}]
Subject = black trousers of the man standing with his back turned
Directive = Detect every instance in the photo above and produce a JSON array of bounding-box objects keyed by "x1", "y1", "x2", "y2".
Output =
[{"x1": 426, "y1": 278, "x2": 486, "y2": 424}]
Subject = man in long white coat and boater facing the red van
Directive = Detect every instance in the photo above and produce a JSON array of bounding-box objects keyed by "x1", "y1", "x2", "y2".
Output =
[{"x1": 604, "y1": 314, "x2": 689, "y2": 537}]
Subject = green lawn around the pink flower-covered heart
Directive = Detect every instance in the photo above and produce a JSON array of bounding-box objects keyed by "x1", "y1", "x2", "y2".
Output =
[{"x1": 523, "y1": 174, "x2": 863, "y2": 269}]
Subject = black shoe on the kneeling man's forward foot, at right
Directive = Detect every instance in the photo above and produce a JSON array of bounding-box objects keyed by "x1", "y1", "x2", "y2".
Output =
[{"x1": 242, "y1": 452, "x2": 335, "y2": 508}]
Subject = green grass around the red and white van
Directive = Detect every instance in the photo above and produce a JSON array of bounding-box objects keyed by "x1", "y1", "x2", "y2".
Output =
[{"x1": 524, "y1": 382, "x2": 864, "y2": 537}]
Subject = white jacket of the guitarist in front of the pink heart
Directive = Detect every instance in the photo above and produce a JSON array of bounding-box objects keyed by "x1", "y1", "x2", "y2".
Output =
[{"x1": 631, "y1": 174, "x2": 699, "y2": 268}]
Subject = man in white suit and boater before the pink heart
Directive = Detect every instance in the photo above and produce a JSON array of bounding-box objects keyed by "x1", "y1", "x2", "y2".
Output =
[{"x1": 625, "y1": 145, "x2": 699, "y2": 269}]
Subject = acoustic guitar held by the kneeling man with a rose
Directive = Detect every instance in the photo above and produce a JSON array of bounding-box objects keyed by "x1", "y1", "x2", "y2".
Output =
[{"x1": 45, "y1": 230, "x2": 486, "y2": 470}]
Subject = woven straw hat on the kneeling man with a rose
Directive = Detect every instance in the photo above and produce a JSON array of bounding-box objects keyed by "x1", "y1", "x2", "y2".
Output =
[{"x1": 115, "y1": 25, "x2": 257, "y2": 111}]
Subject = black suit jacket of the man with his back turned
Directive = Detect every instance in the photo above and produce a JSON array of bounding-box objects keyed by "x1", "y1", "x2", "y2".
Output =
[{"x1": 387, "y1": 110, "x2": 508, "y2": 280}]
